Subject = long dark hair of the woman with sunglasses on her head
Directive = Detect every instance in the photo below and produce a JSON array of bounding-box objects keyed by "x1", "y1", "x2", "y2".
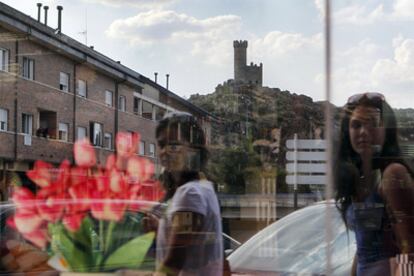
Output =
[{"x1": 334, "y1": 93, "x2": 413, "y2": 224}]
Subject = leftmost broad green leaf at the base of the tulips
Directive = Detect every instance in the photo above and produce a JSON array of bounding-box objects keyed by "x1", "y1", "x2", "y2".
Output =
[{"x1": 49, "y1": 224, "x2": 91, "y2": 272}]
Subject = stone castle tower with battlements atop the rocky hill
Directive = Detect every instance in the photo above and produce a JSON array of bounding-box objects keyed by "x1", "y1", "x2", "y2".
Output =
[{"x1": 233, "y1": 40, "x2": 263, "y2": 86}]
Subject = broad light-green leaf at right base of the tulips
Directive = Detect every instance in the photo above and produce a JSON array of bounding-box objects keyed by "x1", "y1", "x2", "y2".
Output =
[{"x1": 103, "y1": 232, "x2": 155, "y2": 270}]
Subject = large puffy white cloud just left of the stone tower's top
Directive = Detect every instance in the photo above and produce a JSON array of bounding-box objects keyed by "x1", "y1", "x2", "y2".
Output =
[{"x1": 106, "y1": 10, "x2": 241, "y2": 65}]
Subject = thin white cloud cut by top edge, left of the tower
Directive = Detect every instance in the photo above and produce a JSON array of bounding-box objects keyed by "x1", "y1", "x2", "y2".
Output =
[{"x1": 82, "y1": 0, "x2": 178, "y2": 9}]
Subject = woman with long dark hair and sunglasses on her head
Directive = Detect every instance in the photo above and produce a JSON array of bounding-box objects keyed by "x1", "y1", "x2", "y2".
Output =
[{"x1": 335, "y1": 93, "x2": 414, "y2": 275}]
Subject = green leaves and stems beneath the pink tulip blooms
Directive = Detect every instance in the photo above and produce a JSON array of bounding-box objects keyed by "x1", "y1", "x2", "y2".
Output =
[{"x1": 49, "y1": 213, "x2": 155, "y2": 272}]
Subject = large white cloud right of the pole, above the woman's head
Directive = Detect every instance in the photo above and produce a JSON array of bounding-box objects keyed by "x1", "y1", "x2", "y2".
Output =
[{"x1": 326, "y1": 35, "x2": 414, "y2": 107}]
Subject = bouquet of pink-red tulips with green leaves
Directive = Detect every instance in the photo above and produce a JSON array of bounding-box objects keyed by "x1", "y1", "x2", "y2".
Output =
[{"x1": 8, "y1": 133, "x2": 163, "y2": 272}]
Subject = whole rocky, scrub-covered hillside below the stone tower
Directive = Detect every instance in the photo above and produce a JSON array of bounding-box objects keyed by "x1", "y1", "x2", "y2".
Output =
[{"x1": 189, "y1": 82, "x2": 414, "y2": 193}]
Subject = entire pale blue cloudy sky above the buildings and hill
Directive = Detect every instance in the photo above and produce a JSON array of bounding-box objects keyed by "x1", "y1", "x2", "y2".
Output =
[{"x1": 3, "y1": 0, "x2": 414, "y2": 107}]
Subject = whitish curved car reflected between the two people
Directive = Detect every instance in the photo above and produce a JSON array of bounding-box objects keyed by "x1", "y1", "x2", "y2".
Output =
[{"x1": 227, "y1": 202, "x2": 356, "y2": 275}]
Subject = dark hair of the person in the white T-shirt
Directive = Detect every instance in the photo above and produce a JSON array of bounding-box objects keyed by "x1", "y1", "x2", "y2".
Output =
[{"x1": 156, "y1": 112, "x2": 208, "y2": 200}]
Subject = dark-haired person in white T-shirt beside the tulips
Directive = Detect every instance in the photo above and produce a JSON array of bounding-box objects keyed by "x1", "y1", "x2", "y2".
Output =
[{"x1": 156, "y1": 112, "x2": 223, "y2": 275}]
